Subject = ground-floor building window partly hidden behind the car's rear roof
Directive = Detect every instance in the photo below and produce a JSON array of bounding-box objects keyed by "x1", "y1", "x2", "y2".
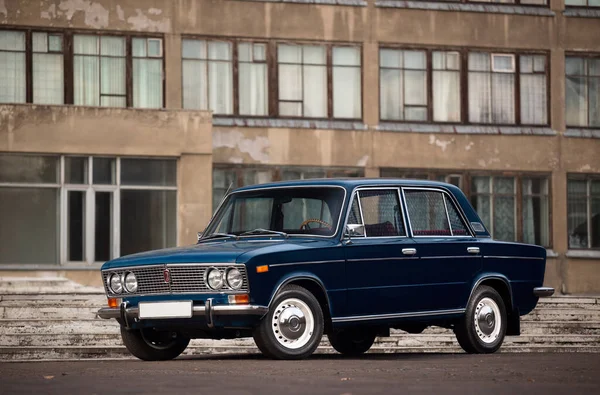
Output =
[{"x1": 381, "y1": 168, "x2": 551, "y2": 247}]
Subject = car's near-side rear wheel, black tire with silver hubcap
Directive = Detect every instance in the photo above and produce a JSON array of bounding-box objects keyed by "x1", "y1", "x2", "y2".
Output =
[{"x1": 454, "y1": 285, "x2": 507, "y2": 354}]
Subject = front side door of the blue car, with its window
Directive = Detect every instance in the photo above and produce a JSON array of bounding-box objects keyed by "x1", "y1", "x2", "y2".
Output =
[{"x1": 344, "y1": 188, "x2": 425, "y2": 321}]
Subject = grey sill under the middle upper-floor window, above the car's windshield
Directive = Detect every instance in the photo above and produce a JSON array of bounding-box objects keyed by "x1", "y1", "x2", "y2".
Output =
[{"x1": 213, "y1": 116, "x2": 367, "y2": 131}]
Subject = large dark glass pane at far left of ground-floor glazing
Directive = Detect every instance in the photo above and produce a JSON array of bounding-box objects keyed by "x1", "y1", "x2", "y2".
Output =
[{"x1": 0, "y1": 187, "x2": 59, "y2": 264}]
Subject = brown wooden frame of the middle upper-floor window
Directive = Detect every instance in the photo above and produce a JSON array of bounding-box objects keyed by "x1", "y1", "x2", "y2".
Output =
[{"x1": 181, "y1": 34, "x2": 365, "y2": 122}]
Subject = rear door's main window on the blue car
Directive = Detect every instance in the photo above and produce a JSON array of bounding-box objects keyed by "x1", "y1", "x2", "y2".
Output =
[{"x1": 404, "y1": 189, "x2": 452, "y2": 236}]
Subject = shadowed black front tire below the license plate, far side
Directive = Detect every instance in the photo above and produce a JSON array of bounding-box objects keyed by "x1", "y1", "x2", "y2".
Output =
[{"x1": 121, "y1": 326, "x2": 190, "y2": 361}]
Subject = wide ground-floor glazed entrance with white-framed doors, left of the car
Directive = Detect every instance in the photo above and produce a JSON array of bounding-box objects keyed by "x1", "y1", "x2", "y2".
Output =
[{"x1": 0, "y1": 154, "x2": 177, "y2": 264}]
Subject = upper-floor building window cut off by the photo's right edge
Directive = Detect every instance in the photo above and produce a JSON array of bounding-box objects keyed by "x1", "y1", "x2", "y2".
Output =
[{"x1": 565, "y1": 56, "x2": 600, "y2": 127}]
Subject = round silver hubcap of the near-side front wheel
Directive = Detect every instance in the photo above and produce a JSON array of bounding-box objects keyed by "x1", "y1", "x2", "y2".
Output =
[{"x1": 271, "y1": 298, "x2": 315, "y2": 349}]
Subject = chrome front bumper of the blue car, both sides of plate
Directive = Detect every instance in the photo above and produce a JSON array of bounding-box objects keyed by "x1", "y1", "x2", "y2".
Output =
[{"x1": 97, "y1": 299, "x2": 269, "y2": 328}]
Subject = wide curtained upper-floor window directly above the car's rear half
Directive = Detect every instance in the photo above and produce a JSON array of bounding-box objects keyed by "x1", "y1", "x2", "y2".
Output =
[{"x1": 379, "y1": 48, "x2": 548, "y2": 125}]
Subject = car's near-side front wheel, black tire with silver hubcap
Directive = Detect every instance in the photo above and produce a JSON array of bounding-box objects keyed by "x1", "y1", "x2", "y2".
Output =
[{"x1": 253, "y1": 285, "x2": 324, "y2": 359}]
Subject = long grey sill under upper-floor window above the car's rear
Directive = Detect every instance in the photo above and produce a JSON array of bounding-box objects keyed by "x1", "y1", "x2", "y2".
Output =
[{"x1": 376, "y1": 123, "x2": 556, "y2": 136}]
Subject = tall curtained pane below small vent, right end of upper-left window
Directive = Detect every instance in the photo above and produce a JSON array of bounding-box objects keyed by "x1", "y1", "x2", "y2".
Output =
[{"x1": 133, "y1": 59, "x2": 163, "y2": 108}]
